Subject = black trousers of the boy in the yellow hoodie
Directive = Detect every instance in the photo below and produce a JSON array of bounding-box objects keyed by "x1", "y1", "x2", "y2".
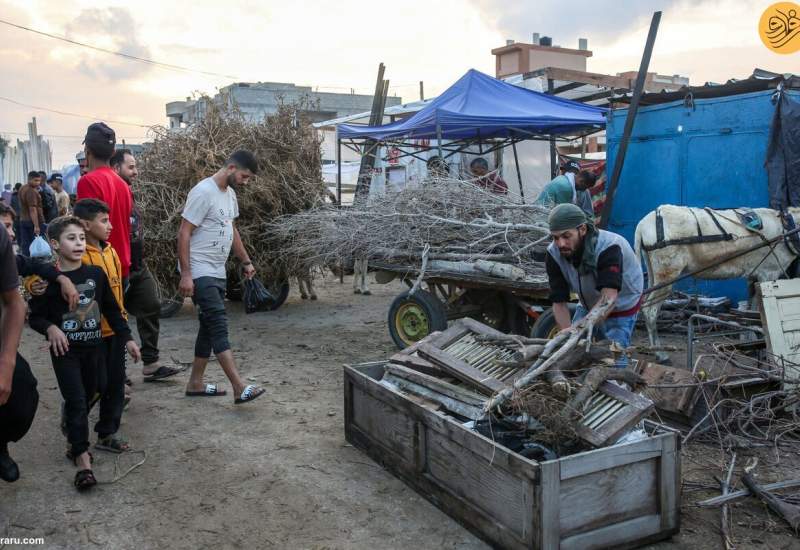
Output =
[{"x1": 94, "y1": 336, "x2": 125, "y2": 438}]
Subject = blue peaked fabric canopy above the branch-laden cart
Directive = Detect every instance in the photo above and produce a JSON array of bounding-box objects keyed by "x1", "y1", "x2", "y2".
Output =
[{"x1": 338, "y1": 69, "x2": 607, "y2": 140}]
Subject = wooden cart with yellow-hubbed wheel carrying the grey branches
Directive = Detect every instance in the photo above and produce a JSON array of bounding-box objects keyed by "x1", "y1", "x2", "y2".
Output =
[{"x1": 370, "y1": 261, "x2": 556, "y2": 349}]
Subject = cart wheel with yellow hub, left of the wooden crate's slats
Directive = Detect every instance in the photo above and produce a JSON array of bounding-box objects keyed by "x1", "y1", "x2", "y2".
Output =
[{"x1": 389, "y1": 290, "x2": 447, "y2": 349}]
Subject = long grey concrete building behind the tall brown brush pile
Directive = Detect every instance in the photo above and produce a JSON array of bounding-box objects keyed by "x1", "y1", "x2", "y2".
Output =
[{"x1": 167, "y1": 82, "x2": 401, "y2": 129}]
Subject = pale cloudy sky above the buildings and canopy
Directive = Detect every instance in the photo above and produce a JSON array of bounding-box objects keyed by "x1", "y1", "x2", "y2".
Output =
[{"x1": 0, "y1": 0, "x2": 800, "y2": 166}]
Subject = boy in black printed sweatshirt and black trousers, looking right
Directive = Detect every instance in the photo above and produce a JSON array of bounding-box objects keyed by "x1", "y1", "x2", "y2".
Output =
[{"x1": 30, "y1": 216, "x2": 140, "y2": 490}]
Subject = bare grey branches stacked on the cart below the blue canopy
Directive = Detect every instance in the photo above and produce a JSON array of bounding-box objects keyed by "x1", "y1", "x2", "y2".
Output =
[{"x1": 267, "y1": 179, "x2": 548, "y2": 280}]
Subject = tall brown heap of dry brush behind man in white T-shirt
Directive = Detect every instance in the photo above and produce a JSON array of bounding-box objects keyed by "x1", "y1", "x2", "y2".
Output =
[{"x1": 134, "y1": 97, "x2": 325, "y2": 298}]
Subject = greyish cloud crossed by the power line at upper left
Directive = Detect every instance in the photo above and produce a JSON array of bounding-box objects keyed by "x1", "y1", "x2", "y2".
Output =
[{"x1": 64, "y1": 7, "x2": 151, "y2": 81}]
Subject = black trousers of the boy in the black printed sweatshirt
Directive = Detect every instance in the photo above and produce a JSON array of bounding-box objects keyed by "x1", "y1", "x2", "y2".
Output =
[{"x1": 50, "y1": 346, "x2": 102, "y2": 457}]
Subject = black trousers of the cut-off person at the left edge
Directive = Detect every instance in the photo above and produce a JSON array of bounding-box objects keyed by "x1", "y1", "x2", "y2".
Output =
[{"x1": 0, "y1": 354, "x2": 39, "y2": 450}]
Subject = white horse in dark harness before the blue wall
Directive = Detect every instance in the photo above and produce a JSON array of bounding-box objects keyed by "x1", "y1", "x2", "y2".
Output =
[{"x1": 634, "y1": 205, "x2": 800, "y2": 367}]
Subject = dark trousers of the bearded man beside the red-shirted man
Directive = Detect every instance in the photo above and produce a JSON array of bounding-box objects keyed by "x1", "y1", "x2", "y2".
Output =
[{"x1": 125, "y1": 267, "x2": 161, "y2": 365}]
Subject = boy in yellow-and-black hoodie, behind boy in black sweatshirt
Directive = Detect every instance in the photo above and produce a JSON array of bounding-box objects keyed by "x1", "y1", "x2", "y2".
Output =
[{"x1": 73, "y1": 199, "x2": 130, "y2": 453}]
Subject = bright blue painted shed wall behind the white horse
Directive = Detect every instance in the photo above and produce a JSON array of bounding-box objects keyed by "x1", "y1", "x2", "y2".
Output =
[{"x1": 606, "y1": 91, "x2": 800, "y2": 301}]
